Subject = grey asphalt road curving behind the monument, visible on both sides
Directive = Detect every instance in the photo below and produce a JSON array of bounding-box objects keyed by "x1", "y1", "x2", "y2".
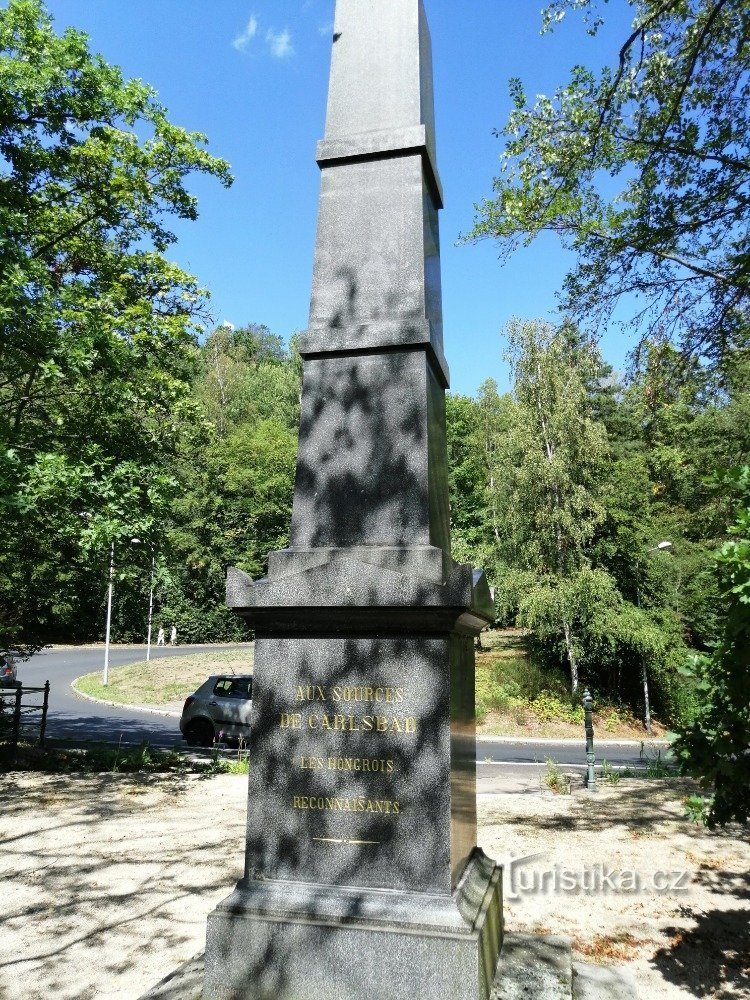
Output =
[{"x1": 18, "y1": 646, "x2": 664, "y2": 776}]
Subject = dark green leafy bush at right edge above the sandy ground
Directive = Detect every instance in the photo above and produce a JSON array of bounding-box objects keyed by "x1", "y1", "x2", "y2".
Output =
[{"x1": 672, "y1": 466, "x2": 750, "y2": 827}]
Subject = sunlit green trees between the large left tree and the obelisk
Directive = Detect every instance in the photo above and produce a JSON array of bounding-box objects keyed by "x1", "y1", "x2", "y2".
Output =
[{"x1": 166, "y1": 324, "x2": 301, "y2": 641}]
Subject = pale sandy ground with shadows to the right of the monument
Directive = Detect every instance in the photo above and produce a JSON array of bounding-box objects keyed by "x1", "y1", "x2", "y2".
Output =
[{"x1": 479, "y1": 780, "x2": 750, "y2": 1000}]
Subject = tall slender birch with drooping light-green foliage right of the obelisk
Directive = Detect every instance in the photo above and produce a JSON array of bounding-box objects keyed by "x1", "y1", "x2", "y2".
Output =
[{"x1": 493, "y1": 321, "x2": 613, "y2": 692}]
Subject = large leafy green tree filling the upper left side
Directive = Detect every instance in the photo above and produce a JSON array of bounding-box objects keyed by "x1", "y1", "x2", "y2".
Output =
[{"x1": 0, "y1": 0, "x2": 231, "y2": 646}]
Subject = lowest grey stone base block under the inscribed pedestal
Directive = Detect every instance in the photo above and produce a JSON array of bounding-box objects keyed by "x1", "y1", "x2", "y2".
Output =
[{"x1": 203, "y1": 849, "x2": 503, "y2": 1000}]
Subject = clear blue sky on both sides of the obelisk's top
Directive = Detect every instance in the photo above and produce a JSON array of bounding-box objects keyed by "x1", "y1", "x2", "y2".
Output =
[{"x1": 41, "y1": 0, "x2": 632, "y2": 393}]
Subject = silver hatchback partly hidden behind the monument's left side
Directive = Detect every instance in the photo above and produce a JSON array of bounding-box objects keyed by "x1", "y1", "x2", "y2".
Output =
[{"x1": 180, "y1": 674, "x2": 253, "y2": 747}]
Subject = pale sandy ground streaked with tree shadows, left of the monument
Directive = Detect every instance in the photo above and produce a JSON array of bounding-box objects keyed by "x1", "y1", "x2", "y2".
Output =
[{"x1": 0, "y1": 773, "x2": 244, "y2": 1000}]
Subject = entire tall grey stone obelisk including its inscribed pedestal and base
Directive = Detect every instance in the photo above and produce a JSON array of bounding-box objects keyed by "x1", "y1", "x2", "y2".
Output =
[{"x1": 204, "y1": 0, "x2": 502, "y2": 1000}]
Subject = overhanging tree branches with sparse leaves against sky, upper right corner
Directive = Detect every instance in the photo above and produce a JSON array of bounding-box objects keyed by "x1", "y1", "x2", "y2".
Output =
[{"x1": 468, "y1": 0, "x2": 750, "y2": 361}]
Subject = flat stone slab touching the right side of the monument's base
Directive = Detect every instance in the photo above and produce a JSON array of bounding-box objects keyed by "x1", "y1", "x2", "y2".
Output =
[{"x1": 490, "y1": 933, "x2": 573, "y2": 1000}]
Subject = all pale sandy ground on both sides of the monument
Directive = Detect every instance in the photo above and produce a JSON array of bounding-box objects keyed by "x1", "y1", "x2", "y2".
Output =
[{"x1": 0, "y1": 773, "x2": 750, "y2": 1000}]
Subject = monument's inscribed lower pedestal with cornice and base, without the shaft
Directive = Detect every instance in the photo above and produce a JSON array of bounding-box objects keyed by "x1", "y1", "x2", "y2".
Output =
[{"x1": 204, "y1": 550, "x2": 502, "y2": 1000}]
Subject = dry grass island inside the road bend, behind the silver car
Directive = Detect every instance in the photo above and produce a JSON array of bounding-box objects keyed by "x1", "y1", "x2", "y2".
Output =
[{"x1": 73, "y1": 646, "x2": 254, "y2": 707}]
